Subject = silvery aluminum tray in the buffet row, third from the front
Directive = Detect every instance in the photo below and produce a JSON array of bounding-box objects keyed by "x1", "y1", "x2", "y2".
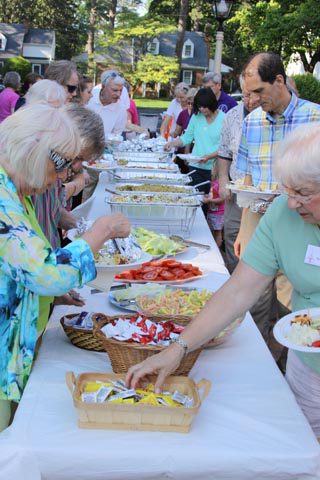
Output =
[{"x1": 114, "y1": 170, "x2": 192, "y2": 185}]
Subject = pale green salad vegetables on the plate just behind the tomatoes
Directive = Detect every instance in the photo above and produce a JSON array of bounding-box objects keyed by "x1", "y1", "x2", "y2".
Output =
[{"x1": 132, "y1": 227, "x2": 188, "y2": 257}]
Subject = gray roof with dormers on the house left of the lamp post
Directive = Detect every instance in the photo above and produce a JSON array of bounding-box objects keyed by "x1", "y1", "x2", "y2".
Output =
[{"x1": 157, "y1": 32, "x2": 208, "y2": 69}]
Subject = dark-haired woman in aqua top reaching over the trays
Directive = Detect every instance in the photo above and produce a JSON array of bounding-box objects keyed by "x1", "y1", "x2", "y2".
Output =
[{"x1": 165, "y1": 88, "x2": 224, "y2": 193}]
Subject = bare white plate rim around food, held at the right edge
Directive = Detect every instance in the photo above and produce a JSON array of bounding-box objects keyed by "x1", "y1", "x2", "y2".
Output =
[{"x1": 273, "y1": 308, "x2": 320, "y2": 353}]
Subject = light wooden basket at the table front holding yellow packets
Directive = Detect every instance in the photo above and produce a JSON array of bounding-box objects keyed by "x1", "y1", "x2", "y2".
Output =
[{"x1": 66, "y1": 372, "x2": 211, "y2": 433}]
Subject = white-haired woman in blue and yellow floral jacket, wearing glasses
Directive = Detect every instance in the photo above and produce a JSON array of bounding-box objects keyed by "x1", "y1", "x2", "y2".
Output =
[{"x1": 0, "y1": 105, "x2": 130, "y2": 430}]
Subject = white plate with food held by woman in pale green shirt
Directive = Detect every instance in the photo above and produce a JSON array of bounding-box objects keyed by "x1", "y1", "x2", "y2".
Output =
[{"x1": 273, "y1": 308, "x2": 320, "y2": 353}]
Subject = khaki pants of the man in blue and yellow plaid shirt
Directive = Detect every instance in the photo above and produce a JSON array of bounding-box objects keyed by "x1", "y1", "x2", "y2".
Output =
[{"x1": 240, "y1": 210, "x2": 292, "y2": 340}]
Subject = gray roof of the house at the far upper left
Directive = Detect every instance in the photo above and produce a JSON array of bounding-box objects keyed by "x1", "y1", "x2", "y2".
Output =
[{"x1": 0, "y1": 23, "x2": 55, "y2": 58}]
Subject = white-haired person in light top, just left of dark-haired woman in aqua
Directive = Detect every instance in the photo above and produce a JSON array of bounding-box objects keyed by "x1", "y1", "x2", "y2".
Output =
[{"x1": 160, "y1": 82, "x2": 189, "y2": 140}]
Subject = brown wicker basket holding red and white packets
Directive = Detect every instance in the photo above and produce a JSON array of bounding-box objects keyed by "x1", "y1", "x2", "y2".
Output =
[{"x1": 93, "y1": 315, "x2": 202, "y2": 375}]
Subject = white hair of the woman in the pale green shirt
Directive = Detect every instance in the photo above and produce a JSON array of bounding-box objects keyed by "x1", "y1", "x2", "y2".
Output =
[{"x1": 274, "y1": 122, "x2": 320, "y2": 188}]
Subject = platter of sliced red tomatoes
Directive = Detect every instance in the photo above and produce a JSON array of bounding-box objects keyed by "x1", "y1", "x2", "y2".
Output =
[{"x1": 115, "y1": 258, "x2": 203, "y2": 284}]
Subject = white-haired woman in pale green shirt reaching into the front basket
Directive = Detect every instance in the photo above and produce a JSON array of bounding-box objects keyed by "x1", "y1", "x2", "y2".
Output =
[{"x1": 127, "y1": 124, "x2": 320, "y2": 437}]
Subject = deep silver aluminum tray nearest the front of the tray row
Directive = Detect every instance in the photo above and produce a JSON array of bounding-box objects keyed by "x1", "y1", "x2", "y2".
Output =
[{"x1": 106, "y1": 193, "x2": 201, "y2": 234}]
